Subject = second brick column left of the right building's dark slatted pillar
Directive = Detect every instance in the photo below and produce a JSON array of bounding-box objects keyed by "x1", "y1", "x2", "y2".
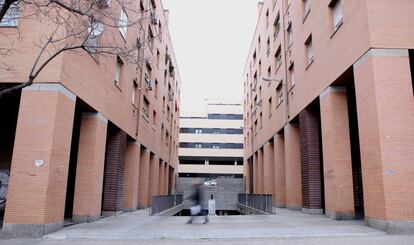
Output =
[{"x1": 273, "y1": 134, "x2": 286, "y2": 208}]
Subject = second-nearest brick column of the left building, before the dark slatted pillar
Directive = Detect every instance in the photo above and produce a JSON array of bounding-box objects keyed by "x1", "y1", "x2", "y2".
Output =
[{"x1": 72, "y1": 112, "x2": 108, "y2": 223}]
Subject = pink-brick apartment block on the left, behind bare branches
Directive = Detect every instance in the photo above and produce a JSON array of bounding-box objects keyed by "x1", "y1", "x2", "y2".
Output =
[{"x1": 0, "y1": 0, "x2": 181, "y2": 236}]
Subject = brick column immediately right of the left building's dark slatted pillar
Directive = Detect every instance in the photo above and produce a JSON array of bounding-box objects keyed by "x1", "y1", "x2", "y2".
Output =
[{"x1": 123, "y1": 141, "x2": 141, "y2": 212}]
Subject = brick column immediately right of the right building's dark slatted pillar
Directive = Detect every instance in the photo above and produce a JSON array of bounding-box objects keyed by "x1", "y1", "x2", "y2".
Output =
[{"x1": 320, "y1": 87, "x2": 355, "y2": 219}]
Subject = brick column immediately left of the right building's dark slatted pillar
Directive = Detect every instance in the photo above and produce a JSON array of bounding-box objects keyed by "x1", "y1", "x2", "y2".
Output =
[{"x1": 284, "y1": 123, "x2": 302, "y2": 209}]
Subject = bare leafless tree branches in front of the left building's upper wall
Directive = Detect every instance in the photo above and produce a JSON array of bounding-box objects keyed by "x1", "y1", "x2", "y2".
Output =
[{"x1": 0, "y1": 0, "x2": 162, "y2": 98}]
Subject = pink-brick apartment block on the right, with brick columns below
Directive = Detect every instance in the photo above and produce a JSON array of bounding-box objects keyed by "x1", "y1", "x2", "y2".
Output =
[{"x1": 243, "y1": 0, "x2": 414, "y2": 233}]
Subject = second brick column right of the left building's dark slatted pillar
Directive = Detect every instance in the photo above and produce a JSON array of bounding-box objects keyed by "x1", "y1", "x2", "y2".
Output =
[{"x1": 138, "y1": 148, "x2": 150, "y2": 208}]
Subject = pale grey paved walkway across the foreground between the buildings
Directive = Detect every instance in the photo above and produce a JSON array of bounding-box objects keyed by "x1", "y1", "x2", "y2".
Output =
[{"x1": 0, "y1": 209, "x2": 414, "y2": 245}]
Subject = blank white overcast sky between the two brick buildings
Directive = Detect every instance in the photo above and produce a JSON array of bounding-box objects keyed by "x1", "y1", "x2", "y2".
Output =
[{"x1": 162, "y1": 0, "x2": 258, "y2": 111}]
